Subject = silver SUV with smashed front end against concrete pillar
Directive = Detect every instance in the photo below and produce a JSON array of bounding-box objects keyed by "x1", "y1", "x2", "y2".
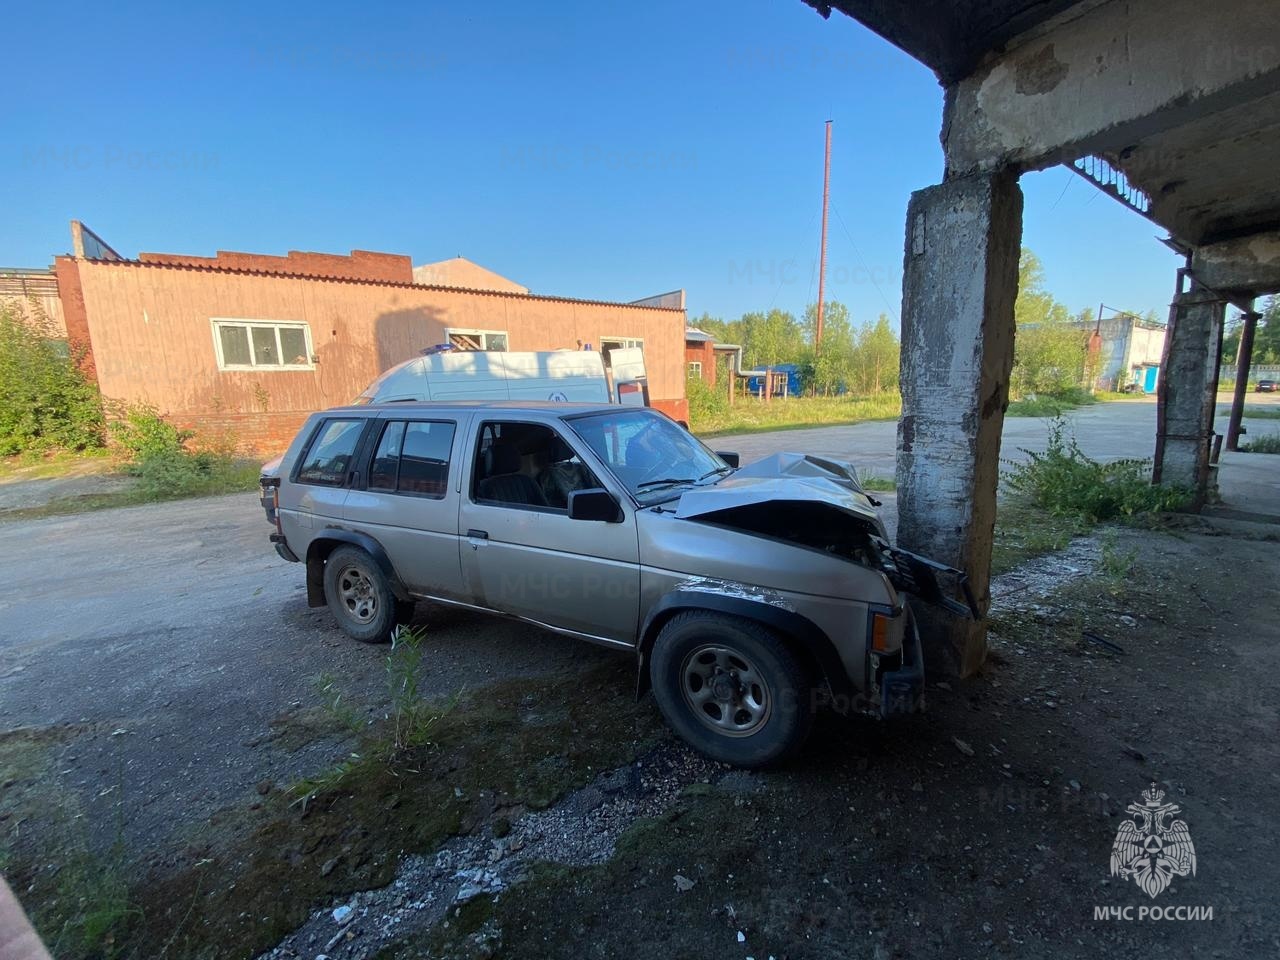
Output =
[{"x1": 262, "y1": 403, "x2": 972, "y2": 767}]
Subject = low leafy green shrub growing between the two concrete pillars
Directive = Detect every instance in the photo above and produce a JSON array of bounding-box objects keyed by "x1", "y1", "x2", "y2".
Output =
[{"x1": 1006, "y1": 419, "x2": 1190, "y2": 522}]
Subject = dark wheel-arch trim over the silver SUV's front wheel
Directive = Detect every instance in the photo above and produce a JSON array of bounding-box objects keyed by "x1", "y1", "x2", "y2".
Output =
[{"x1": 636, "y1": 577, "x2": 856, "y2": 699}]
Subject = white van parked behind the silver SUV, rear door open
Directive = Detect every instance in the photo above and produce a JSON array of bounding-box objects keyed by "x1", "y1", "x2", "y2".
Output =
[{"x1": 356, "y1": 348, "x2": 648, "y2": 403}]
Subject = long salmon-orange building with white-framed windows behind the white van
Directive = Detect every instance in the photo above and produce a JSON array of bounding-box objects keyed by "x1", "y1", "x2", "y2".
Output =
[{"x1": 54, "y1": 223, "x2": 687, "y2": 452}]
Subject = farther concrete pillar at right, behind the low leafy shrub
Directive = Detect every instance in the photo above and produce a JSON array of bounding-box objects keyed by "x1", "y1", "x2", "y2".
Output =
[{"x1": 1152, "y1": 288, "x2": 1226, "y2": 509}]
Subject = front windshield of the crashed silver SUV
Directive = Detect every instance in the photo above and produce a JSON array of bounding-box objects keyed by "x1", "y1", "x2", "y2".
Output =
[{"x1": 567, "y1": 408, "x2": 732, "y2": 503}]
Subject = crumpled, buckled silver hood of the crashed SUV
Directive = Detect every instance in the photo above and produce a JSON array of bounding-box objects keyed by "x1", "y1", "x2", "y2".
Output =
[{"x1": 676, "y1": 453, "x2": 884, "y2": 535}]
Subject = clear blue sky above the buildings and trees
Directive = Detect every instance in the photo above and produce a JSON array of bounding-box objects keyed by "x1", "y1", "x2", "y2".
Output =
[{"x1": 0, "y1": 0, "x2": 1178, "y2": 321}]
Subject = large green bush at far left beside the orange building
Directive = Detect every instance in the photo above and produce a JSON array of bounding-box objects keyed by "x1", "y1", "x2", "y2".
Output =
[{"x1": 0, "y1": 301, "x2": 104, "y2": 456}]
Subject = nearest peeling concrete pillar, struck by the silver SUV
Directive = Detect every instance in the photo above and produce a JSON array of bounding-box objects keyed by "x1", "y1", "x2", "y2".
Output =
[{"x1": 897, "y1": 172, "x2": 1023, "y2": 676}]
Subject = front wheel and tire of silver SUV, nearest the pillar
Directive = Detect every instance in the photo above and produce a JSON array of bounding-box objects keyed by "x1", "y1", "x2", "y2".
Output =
[{"x1": 650, "y1": 611, "x2": 813, "y2": 769}]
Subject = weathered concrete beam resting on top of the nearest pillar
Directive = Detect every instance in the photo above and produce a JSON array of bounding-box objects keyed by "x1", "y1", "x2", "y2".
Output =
[{"x1": 943, "y1": 0, "x2": 1280, "y2": 179}]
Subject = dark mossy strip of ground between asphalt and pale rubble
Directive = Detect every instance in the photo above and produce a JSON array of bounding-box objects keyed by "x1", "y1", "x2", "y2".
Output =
[{"x1": 120, "y1": 660, "x2": 659, "y2": 957}]
